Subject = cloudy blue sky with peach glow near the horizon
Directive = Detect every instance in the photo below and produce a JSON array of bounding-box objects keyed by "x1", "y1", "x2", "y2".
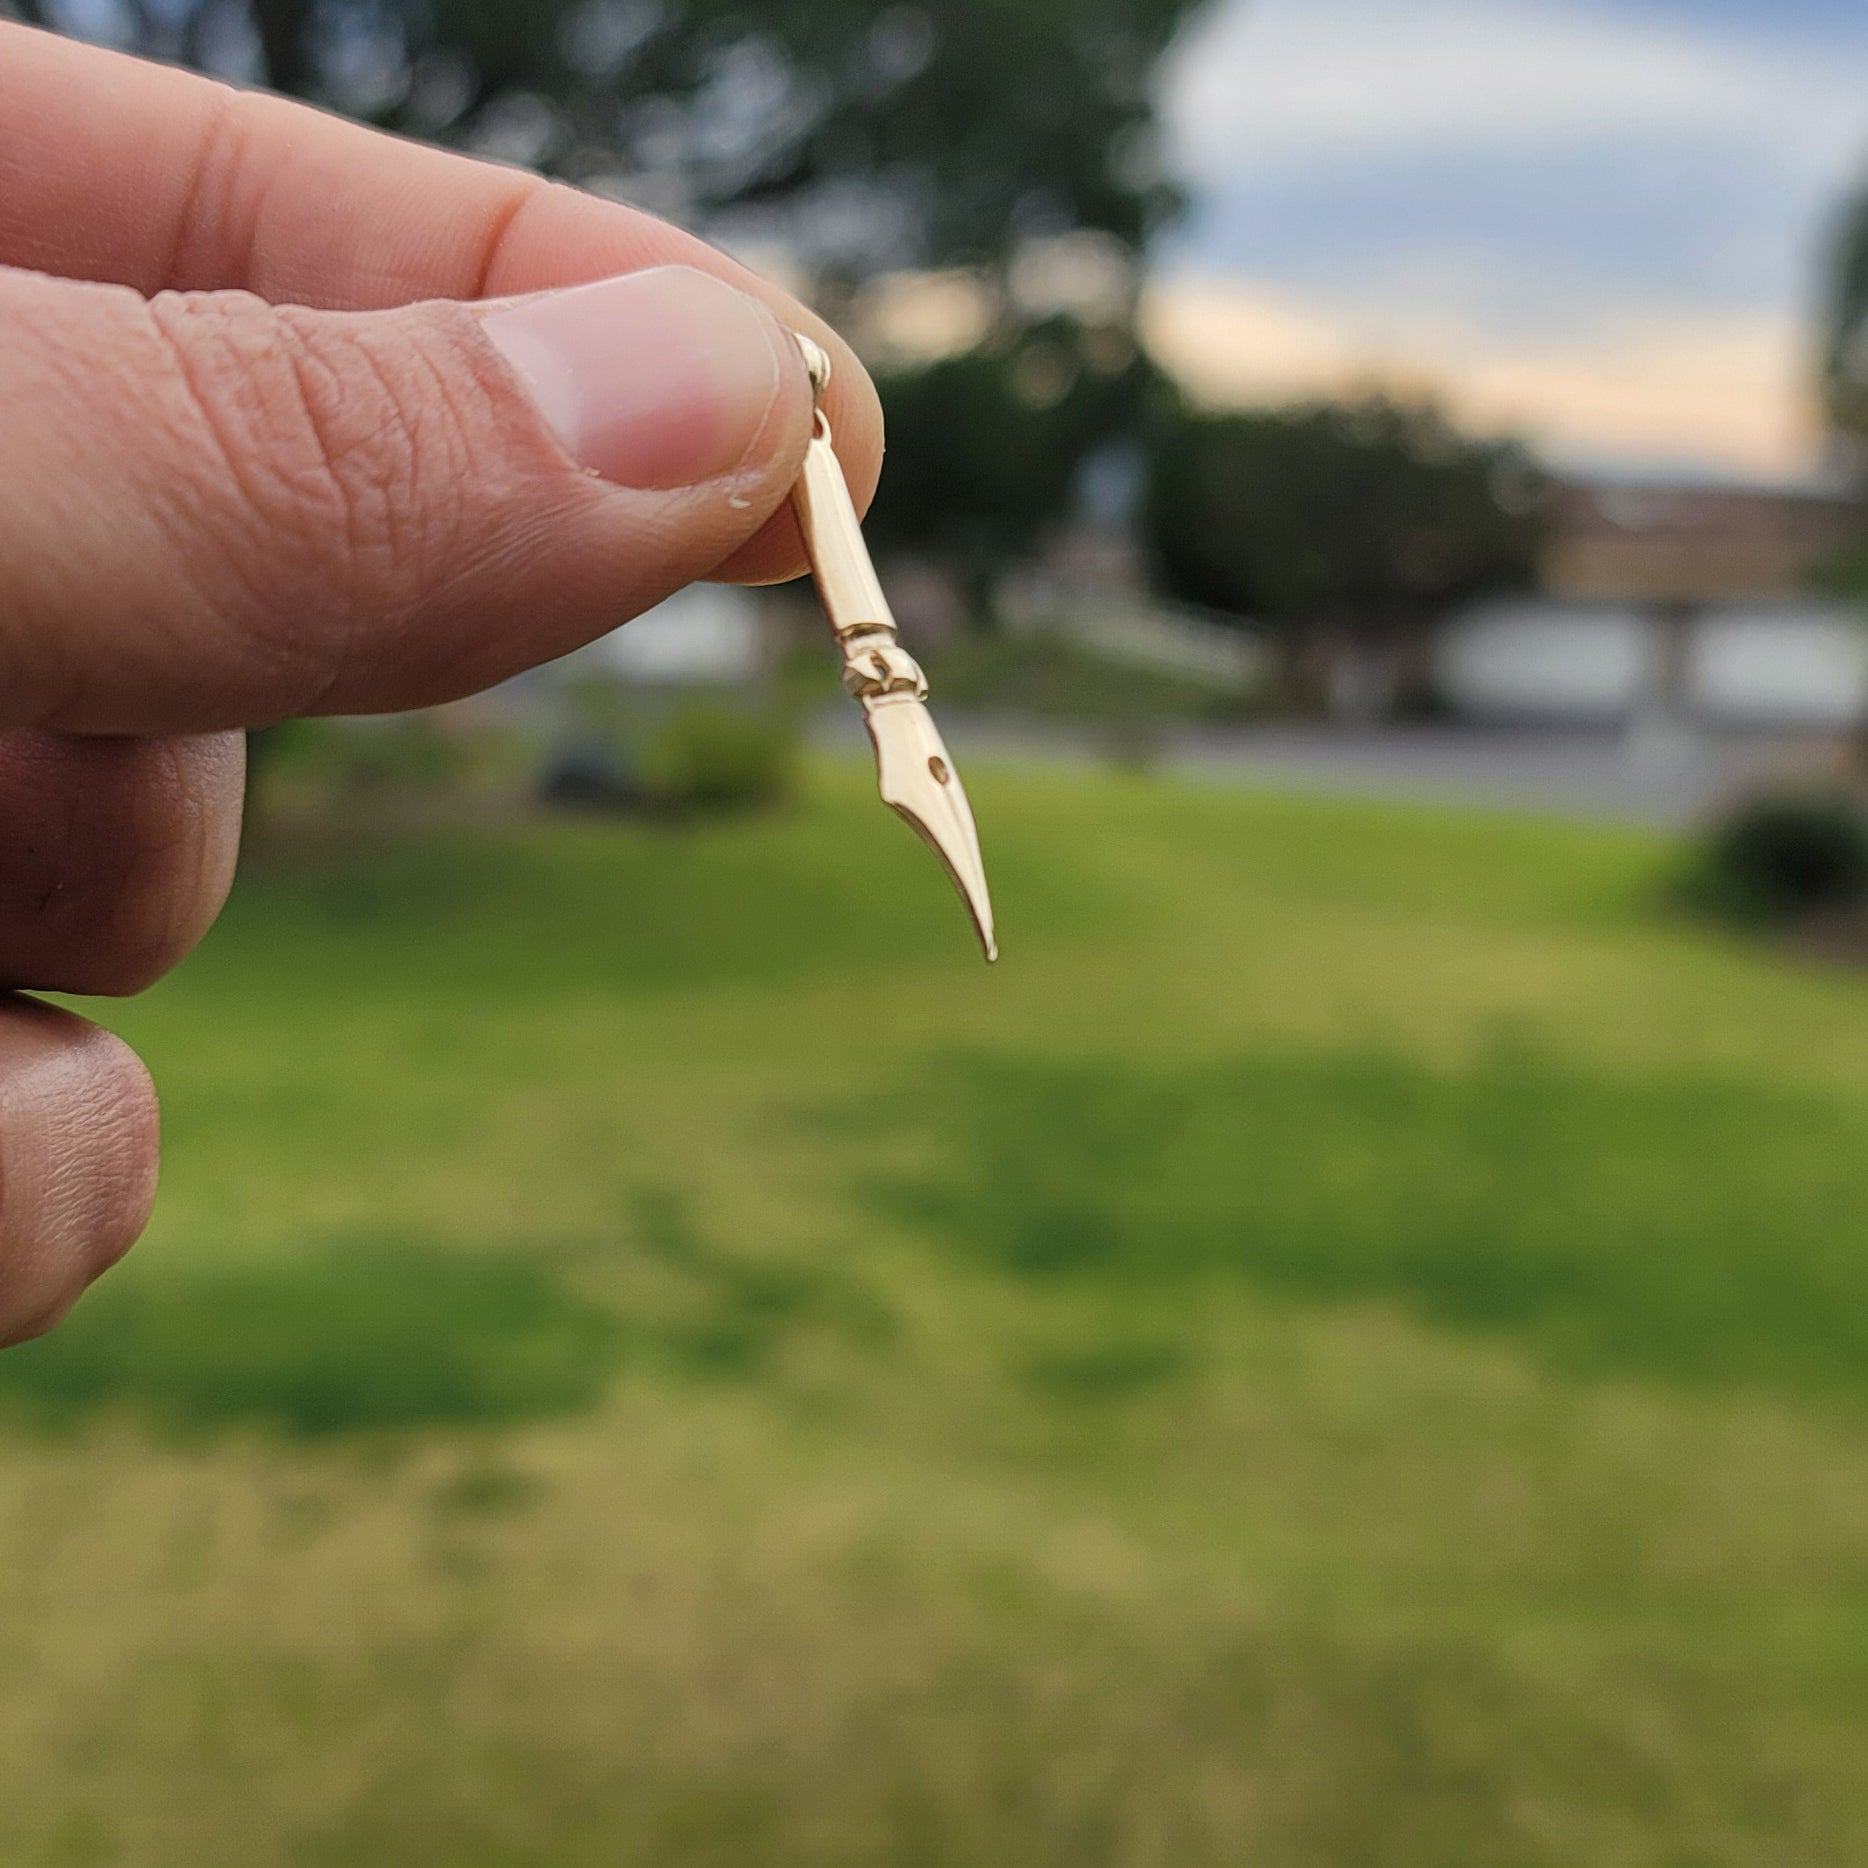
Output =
[{"x1": 1149, "y1": 0, "x2": 1868, "y2": 478}]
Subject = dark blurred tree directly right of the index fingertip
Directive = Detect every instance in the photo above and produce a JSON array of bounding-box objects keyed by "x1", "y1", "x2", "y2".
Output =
[{"x1": 867, "y1": 318, "x2": 1158, "y2": 618}]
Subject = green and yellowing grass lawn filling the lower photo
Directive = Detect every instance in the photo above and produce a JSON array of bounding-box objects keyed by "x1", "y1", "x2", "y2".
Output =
[{"x1": 0, "y1": 768, "x2": 1868, "y2": 1868}]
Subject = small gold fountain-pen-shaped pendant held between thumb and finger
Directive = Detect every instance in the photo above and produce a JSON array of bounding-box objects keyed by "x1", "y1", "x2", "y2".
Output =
[{"x1": 792, "y1": 336, "x2": 999, "y2": 960}]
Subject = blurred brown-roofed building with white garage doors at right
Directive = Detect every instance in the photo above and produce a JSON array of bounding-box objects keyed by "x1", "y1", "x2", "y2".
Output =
[{"x1": 1433, "y1": 482, "x2": 1868, "y2": 732}]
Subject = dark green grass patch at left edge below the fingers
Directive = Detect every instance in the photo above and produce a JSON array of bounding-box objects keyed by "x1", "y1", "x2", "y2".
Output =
[{"x1": 0, "y1": 1238, "x2": 618, "y2": 1436}]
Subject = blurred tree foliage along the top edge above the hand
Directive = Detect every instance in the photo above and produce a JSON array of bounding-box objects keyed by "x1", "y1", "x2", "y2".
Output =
[{"x1": 19, "y1": 0, "x2": 1199, "y2": 288}]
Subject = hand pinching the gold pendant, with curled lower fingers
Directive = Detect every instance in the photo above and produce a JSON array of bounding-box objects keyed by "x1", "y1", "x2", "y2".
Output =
[{"x1": 0, "y1": 24, "x2": 882, "y2": 1341}]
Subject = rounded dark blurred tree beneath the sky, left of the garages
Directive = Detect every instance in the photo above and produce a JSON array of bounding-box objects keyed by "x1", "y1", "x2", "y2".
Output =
[{"x1": 1147, "y1": 398, "x2": 1545, "y2": 704}]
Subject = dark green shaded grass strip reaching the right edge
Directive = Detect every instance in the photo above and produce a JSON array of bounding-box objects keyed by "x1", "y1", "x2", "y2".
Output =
[{"x1": 865, "y1": 1055, "x2": 1868, "y2": 1394}]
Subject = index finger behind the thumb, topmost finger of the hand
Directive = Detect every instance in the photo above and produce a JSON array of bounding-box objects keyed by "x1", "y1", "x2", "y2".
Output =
[{"x1": 0, "y1": 22, "x2": 882, "y2": 579}]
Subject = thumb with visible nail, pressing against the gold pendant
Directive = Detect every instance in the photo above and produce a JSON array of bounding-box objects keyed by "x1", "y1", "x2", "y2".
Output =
[{"x1": 0, "y1": 267, "x2": 811, "y2": 732}]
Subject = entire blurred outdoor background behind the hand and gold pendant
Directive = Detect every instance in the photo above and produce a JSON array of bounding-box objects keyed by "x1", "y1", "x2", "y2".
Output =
[{"x1": 0, "y1": 0, "x2": 1868, "y2": 1868}]
